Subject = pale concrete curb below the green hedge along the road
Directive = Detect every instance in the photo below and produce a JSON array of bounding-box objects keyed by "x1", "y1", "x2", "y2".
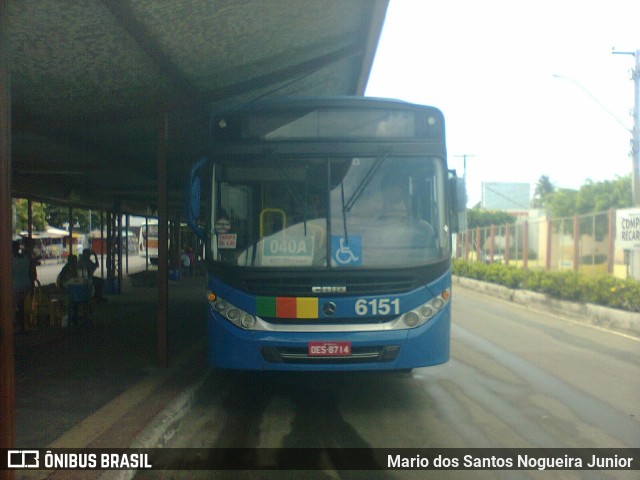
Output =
[{"x1": 452, "y1": 275, "x2": 640, "y2": 337}]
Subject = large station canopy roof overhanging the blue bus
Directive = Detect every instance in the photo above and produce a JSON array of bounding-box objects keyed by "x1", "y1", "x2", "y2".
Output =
[{"x1": 7, "y1": 0, "x2": 387, "y2": 215}]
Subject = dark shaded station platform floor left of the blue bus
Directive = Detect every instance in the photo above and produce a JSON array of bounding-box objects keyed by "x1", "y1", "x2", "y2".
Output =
[{"x1": 14, "y1": 262, "x2": 211, "y2": 478}]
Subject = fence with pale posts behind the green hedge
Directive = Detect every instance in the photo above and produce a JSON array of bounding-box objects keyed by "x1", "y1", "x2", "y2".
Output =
[{"x1": 455, "y1": 210, "x2": 630, "y2": 278}]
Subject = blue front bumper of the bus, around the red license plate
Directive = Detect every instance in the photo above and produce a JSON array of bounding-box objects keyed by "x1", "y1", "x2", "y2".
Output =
[{"x1": 207, "y1": 308, "x2": 451, "y2": 371}]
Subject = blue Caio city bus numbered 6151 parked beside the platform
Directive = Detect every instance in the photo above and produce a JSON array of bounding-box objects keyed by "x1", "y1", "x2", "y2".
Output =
[{"x1": 186, "y1": 97, "x2": 466, "y2": 371}]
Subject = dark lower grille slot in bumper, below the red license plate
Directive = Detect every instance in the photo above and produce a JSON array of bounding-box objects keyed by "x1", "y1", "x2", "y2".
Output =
[{"x1": 262, "y1": 345, "x2": 400, "y2": 365}]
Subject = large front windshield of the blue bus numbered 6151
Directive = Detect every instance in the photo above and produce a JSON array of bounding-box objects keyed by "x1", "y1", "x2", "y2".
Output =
[{"x1": 209, "y1": 156, "x2": 450, "y2": 269}]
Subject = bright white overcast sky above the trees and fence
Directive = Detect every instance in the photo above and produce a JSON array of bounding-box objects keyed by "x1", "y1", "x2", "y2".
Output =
[{"x1": 366, "y1": 0, "x2": 640, "y2": 207}]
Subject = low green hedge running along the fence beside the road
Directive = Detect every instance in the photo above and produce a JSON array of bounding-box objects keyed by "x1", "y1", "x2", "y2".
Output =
[{"x1": 453, "y1": 259, "x2": 640, "y2": 312}]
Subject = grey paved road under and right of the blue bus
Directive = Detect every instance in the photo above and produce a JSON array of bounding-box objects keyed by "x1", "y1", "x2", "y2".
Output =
[{"x1": 137, "y1": 288, "x2": 640, "y2": 479}]
